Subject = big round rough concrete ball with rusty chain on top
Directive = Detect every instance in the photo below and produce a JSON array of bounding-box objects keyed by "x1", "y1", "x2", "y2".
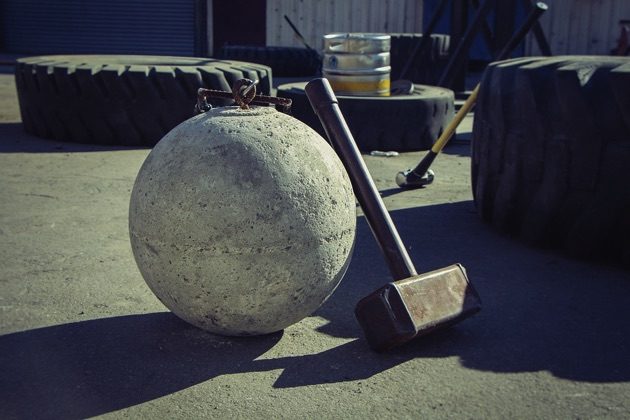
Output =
[{"x1": 129, "y1": 107, "x2": 356, "y2": 335}]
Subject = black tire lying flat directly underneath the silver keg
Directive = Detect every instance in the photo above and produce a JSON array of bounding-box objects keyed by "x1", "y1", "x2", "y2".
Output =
[{"x1": 277, "y1": 83, "x2": 454, "y2": 152}]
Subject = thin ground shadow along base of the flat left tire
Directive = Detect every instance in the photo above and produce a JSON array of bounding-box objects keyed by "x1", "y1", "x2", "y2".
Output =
[{"x1": 0, "y1": 123, "x2": 148, "y2": 153}]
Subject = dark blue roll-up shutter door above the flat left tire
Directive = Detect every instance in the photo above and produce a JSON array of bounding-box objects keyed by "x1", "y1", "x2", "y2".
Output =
[{"x1": 0, "y1": 0, "x2": 199, "y2": 55}]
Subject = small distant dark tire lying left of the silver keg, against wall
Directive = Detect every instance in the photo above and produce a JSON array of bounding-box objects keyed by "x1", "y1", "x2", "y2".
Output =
[{"x1": 218, "y1": 45, "x2": 322, "y2": 77}]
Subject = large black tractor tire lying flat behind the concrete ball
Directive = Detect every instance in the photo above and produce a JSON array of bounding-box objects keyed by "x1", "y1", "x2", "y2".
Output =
[{"x1": 15, "y1": 55, "x2": 272, "y2": 146}]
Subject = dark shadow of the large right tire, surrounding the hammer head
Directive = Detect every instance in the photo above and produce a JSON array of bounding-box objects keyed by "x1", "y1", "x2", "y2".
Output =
[{"x1": 318, "y1": 201, "x2": 630, "y2": 382}]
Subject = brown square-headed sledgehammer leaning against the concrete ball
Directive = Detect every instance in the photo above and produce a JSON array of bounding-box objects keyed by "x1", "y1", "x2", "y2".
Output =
[{"x1": 305, "y1": 79, "x2": 481, "y2": 351}]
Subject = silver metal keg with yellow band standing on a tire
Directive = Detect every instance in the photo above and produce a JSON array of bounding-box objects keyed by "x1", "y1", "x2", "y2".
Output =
[{"x1": 322, "y1": 33, "x2": 391, "y2": 96}]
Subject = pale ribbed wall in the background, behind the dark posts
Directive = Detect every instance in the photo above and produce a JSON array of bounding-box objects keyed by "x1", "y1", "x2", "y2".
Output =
[{"x1": 207, "y1": 0, "x2": 630, "y2": 55}]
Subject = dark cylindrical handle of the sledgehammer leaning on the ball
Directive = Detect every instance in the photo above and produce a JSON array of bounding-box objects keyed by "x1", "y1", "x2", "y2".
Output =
[{"x1": 305, "y1": 79, "x2": 418, "y2": 280}]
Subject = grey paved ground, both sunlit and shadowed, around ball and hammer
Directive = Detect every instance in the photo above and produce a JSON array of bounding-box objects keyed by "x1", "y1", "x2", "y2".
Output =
[{"x1": 0, "y1": 70, "x2": 630, "y2": 419}]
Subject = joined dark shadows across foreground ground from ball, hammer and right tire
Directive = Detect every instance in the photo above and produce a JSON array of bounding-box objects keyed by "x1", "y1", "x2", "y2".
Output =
[{"x1": 0, "y1": 202, "x2": 630, "y2": 418}]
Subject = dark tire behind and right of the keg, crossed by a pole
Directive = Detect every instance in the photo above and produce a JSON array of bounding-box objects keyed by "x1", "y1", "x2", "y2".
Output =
[{"x1": 390, "y1": 33, "x2": 451, "y2": 85}]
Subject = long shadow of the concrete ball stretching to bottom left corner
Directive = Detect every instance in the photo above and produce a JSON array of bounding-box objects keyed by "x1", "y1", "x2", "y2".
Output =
[{"x1": 0, "y1": 312, "x2": 282, "y2": 419}]
